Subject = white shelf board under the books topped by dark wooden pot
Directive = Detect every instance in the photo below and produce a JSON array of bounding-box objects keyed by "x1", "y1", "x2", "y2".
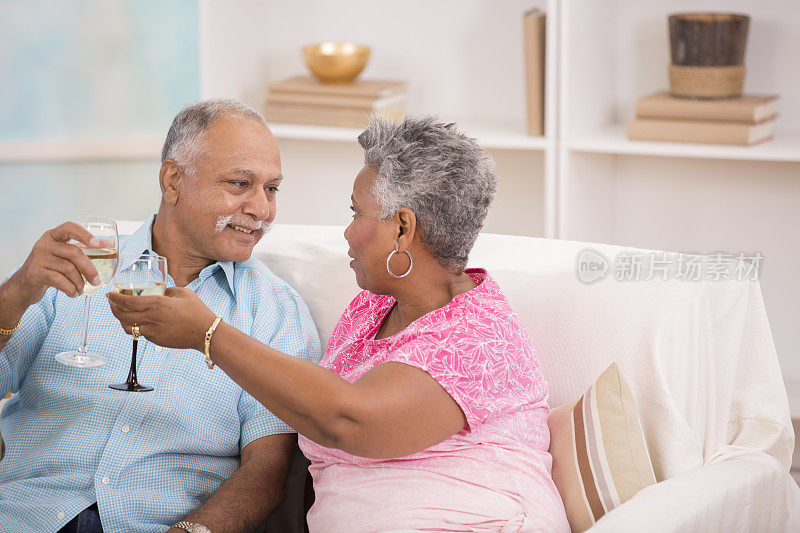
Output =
[{"x1": 566, "y1": 124, "x2": 800, "y2": 162}]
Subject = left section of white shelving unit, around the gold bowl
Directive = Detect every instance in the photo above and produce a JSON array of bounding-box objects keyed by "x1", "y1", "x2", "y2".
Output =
[{"x1": 201, "y1": 0, "x2": 558, "y2": 237}]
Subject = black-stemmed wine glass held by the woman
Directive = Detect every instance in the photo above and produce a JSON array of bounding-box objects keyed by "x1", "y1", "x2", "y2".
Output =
[{"x1": 109, "y1": 254, "x2": 167, "y2": 392}]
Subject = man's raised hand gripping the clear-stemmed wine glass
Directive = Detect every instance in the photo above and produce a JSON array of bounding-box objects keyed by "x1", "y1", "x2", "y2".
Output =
[{"x1": 8, "y1": 222, "x2": 100, "y2": 308}]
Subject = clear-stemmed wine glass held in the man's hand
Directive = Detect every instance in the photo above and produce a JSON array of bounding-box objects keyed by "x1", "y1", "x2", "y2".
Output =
[{"x1": 56, "y1": 216, "x2": 119, "y2": 368}]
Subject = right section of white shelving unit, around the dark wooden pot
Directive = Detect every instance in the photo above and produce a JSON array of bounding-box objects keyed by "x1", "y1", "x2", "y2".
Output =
[{"x1": 557, "y1": 0, "x2": 800, "y2": 394}]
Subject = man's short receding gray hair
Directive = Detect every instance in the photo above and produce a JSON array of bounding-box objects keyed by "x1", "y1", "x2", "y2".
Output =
[{"x1": 161, "y1": 99, "x2": 268, "y2": 170}]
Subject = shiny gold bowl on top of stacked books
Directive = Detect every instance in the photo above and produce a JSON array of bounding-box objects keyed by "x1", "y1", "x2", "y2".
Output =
[{"x1": 303, "y1": 42, "x2": 370, "y2": 83}]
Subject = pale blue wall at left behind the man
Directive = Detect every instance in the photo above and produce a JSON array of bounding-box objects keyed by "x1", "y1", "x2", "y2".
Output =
[{"x1": 0, "y1": 0, "x2": 200, "y2": 273}]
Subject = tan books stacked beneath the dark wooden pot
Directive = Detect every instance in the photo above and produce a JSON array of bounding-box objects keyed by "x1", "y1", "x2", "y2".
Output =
[{"x1": 628, "y1": 92, "x2": 778, "y2": 145}]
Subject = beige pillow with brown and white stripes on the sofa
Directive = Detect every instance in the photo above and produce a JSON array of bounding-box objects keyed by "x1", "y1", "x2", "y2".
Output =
[{"x1": 547, "y1": 363, "x2": 656, "y2": 532}]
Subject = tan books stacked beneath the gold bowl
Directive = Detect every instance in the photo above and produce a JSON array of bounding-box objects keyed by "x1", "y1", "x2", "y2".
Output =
[{"x1": 264, "y1": 76, "x2": 406, "y2": 128}]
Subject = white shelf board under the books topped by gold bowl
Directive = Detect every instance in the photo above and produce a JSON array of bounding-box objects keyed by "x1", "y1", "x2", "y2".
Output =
[{"x1": 270, "y1": 122, "x2": 549, "y2": 150}]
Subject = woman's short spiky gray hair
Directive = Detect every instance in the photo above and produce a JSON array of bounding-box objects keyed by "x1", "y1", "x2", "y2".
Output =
[{"x1": 358, "y1": 116, "x2": 497, "y2": 272}]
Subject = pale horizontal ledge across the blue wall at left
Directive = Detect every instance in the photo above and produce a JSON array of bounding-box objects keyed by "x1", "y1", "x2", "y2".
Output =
[{"x1": 0, "y1": 138, "x2": 164, "y2": 163}]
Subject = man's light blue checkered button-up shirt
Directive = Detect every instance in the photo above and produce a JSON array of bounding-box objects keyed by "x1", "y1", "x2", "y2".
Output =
[{"x1": 0, "y1": 217, "x2": 321, "y2": 533}]
